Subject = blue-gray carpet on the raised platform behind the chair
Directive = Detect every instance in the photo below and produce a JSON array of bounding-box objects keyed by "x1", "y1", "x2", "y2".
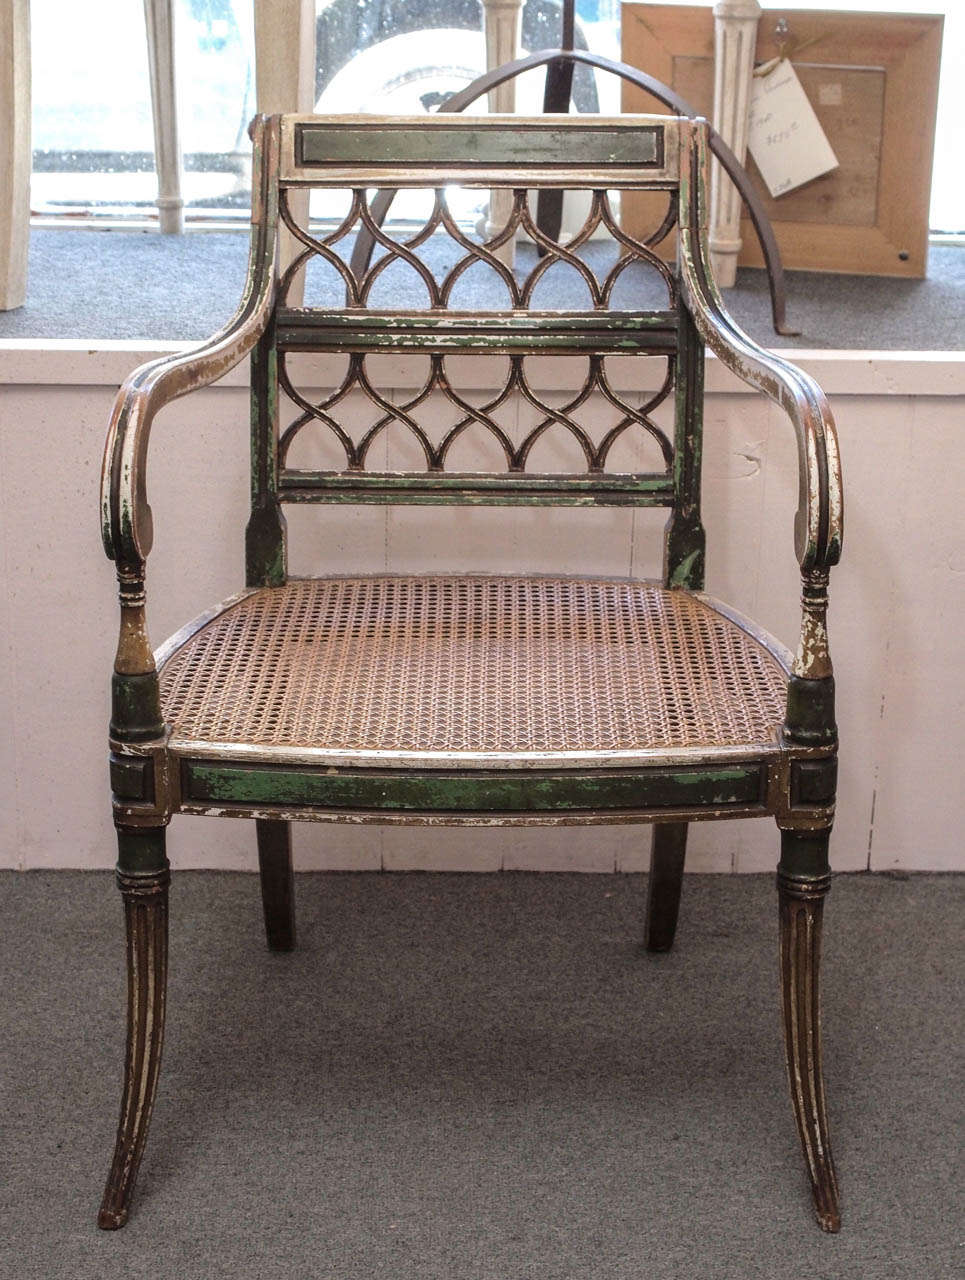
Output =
[{"x1": 0, "y1": 229, "x2": 965, "y2": 351}]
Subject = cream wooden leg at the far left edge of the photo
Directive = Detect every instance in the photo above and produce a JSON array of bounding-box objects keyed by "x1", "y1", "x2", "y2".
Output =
[{"x1": 0, "y1": 0, "x2": 31, "y2": 311}]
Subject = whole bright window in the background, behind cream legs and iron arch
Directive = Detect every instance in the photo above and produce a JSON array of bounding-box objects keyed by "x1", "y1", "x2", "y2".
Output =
[{"x1": 32, "y1": 0, "x2": 619, "y2": 223}]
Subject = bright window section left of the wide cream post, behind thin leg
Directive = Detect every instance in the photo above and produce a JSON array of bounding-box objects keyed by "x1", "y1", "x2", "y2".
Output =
[{"x1": 31, "y1": 0, "x2": 255, "y2": 219}]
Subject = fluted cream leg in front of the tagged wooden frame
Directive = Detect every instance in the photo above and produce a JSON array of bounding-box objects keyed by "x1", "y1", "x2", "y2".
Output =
[{"x1": 710, "y1": 0, "x2": 760, "y2": 288}]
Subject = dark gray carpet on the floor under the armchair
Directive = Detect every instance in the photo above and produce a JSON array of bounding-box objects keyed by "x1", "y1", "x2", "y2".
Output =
[{"x1": 0, "y1": 872, "x2": 965, "y2": 1280}]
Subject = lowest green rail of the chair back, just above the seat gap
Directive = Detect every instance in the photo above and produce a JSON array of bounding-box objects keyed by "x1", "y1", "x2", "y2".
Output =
[{"x1": 279, "y1": 470, "x2": 673, "y2": 507}]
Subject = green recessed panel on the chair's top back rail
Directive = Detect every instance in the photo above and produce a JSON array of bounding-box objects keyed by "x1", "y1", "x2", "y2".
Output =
[{"x1": 294, "y1": 118, "x2": 664, "y2": 172}]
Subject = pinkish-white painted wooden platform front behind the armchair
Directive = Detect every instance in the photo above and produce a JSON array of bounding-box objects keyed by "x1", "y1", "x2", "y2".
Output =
[{"x1": 0, "y1": 343, "x2": 965, "y2": 872}]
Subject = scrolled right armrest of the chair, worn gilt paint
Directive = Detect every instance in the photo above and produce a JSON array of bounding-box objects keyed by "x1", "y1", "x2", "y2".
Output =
[{"x1": 680, "y1": 122, "x2": 843, "y2": 573}]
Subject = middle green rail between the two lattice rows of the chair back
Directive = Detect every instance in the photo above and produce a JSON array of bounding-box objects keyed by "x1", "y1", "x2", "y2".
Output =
[{"x1": 278, "y1": 308, "x2": 677, "y2": 355}]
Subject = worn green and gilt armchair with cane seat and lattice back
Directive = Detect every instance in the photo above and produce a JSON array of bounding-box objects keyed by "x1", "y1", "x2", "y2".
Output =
[{"x1": 99, "y1": 115, "x2": 842, "y2": 1231}]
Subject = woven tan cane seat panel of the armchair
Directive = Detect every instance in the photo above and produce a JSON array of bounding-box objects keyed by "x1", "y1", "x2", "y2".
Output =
[{"x1": 161, "y1": 577, "x2": 786, "y2": 753}]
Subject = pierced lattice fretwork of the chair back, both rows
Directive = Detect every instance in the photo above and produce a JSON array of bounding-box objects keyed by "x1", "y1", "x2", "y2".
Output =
[{"x1": 271, "y1": 189, "x2": 677, "y2": 488}]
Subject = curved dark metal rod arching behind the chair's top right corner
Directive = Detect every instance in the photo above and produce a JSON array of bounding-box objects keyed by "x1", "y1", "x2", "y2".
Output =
[{"x1": 351, "y1": 49, "x2": 800, "y2": 338}]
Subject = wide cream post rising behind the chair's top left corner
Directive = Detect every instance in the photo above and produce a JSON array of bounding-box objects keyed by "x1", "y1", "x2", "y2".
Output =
[{"x1": 255, "y1": 0, "x2": 315, "y2": 307}]
